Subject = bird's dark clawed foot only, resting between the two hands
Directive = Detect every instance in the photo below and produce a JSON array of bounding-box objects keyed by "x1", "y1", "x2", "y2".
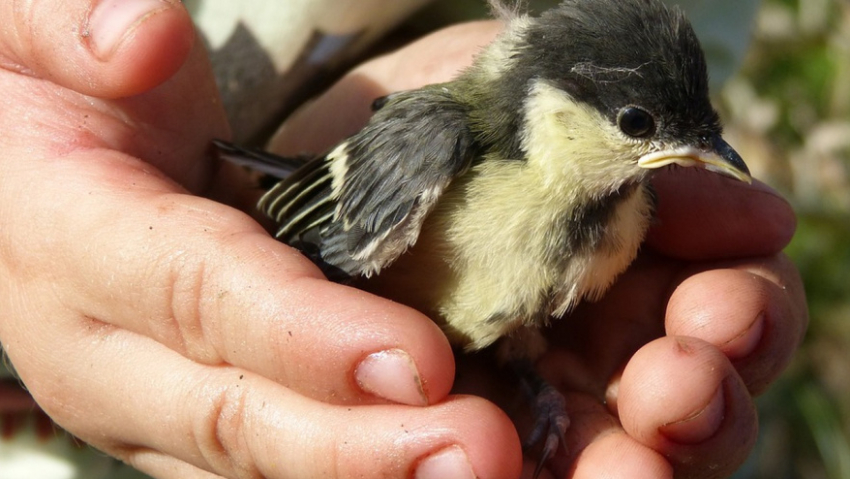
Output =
[{"x1": 523, "y1": 382, "x2": 570, "y2": 479}]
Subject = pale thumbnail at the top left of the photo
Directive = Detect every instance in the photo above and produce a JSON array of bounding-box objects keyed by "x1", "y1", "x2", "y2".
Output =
[{"x1": 86, "y1": 0, "x2": 167, "y2": 60}]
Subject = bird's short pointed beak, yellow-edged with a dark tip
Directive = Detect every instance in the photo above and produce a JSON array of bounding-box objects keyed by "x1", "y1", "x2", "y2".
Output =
[{"x1": 638, "y1": 135, "x2": 753, "y2": 187}]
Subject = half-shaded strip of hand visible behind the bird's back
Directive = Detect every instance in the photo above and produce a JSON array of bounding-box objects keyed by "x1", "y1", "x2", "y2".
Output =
[{"x1": 269, "y1": 21, "x2": 502, "y2": 154}]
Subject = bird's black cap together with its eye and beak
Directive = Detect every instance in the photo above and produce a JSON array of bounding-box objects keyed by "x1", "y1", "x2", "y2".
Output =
[{"x1": 476, "y1": 0, "x2": 749, "y2": 181}]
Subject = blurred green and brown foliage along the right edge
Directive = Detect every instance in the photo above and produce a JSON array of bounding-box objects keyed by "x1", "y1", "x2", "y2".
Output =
[{"x1": 720, "y1": 0, "x2": 850, "y2": 479}]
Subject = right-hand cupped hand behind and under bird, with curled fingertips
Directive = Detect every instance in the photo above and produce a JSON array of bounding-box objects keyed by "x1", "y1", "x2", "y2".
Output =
[{"x1": 271, "y1": 19, "x2": 807, "y2": 478}]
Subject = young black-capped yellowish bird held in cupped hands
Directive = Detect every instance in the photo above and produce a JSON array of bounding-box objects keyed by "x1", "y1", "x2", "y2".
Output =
[{"x1": 215, "y1": 0, "x2": 751, "y2": 476}]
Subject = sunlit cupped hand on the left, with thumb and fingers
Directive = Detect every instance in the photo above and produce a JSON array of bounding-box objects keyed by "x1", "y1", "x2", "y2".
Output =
[{"x1": 0, "y1": 0, "x2": 521, "y2": 479}]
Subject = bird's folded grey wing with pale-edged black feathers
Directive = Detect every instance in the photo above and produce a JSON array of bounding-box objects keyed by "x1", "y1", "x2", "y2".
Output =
[{"x1": 259, "y1": 86, "x2": 475, "y2": 280}]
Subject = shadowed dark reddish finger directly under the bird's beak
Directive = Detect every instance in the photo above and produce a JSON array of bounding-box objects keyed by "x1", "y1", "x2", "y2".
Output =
[{"x1": 647, "y1": 168, "x2": 796, "y2": 260}]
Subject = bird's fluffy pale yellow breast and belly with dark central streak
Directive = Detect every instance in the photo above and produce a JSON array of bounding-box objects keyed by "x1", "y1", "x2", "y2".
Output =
[{"x1": 368, "y1": 163, "x2": 652, "y2": 349}]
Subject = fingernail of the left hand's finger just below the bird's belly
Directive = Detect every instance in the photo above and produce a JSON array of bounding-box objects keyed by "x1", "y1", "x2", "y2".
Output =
[{"x1": 354, "y1": 349, "x2": 428, "y2": 406}]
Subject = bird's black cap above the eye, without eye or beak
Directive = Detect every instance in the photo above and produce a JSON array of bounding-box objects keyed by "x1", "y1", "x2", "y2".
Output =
[{"x1": 524, "y1": 0, "x2": 720, "y2": 139}]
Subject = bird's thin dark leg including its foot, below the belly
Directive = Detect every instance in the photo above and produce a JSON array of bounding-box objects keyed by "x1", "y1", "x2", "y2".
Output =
[{"x1": 499, "y1": 328, "x2": 570, "y2": 479}]
